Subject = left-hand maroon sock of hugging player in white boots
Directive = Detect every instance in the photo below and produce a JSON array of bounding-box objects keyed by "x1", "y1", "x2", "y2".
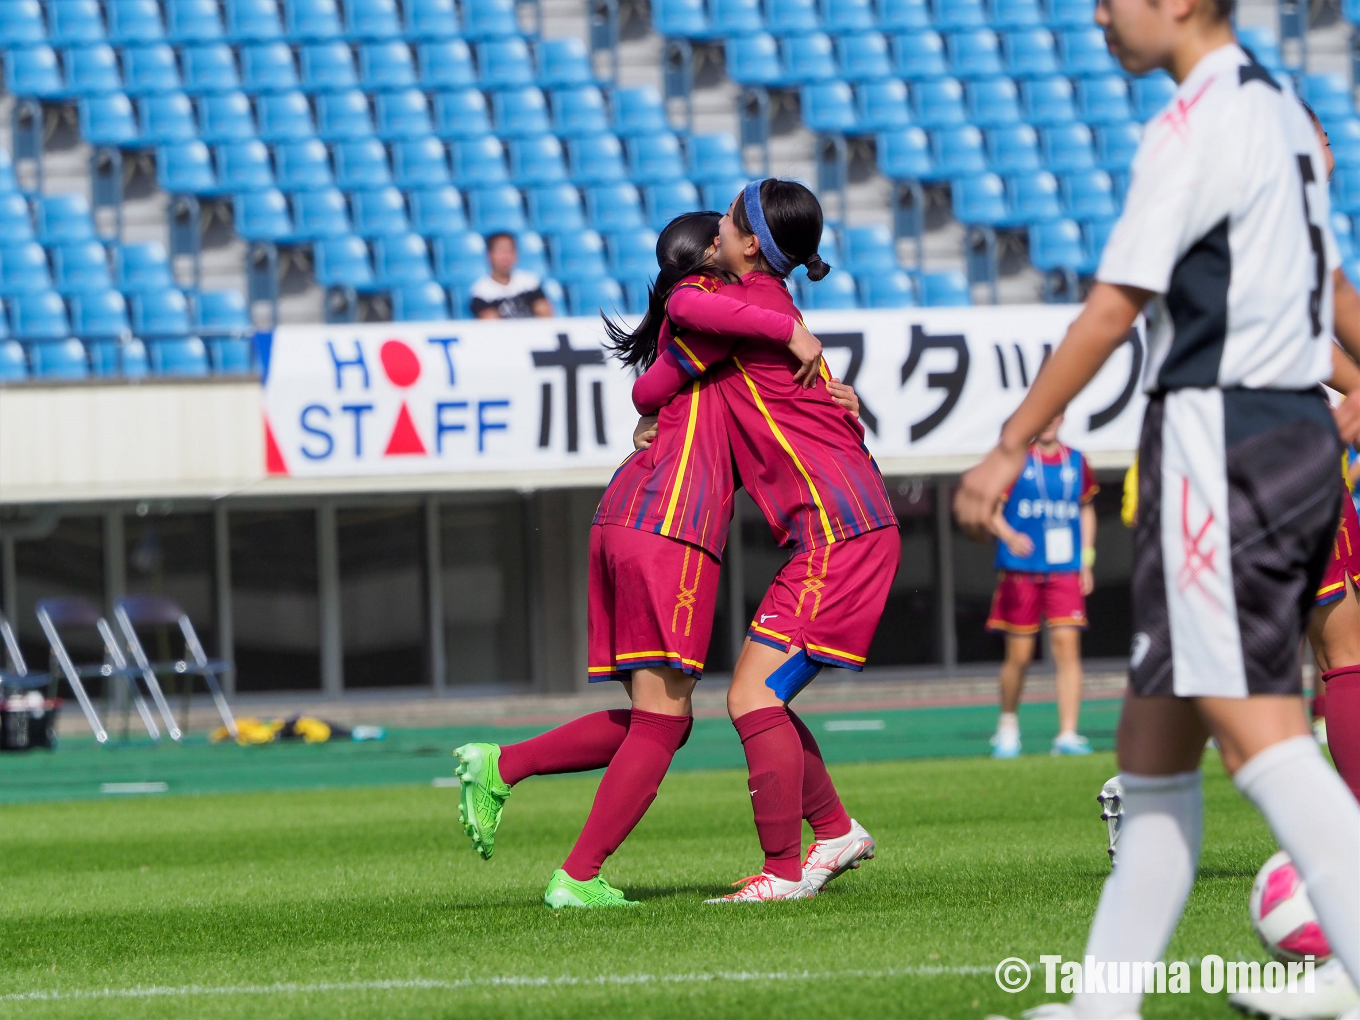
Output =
[{"x1": 732, "y1": 707, "x2": 811, "y2": 881}]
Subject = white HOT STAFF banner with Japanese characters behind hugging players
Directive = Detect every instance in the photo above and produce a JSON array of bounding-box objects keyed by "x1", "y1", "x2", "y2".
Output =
[{"x1": 257, "y1": 306, "x2": 1142, "y2": 484}]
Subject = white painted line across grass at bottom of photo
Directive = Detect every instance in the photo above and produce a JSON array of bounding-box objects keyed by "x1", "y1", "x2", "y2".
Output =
[{"x1": 0, "y1": 966, "x2": 996, "y2": 1002}]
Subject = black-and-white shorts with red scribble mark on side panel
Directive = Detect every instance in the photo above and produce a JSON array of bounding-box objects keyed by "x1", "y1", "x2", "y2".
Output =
[{"x1": 1129, "y1": 389, "x2": 1342, "y2": 698}]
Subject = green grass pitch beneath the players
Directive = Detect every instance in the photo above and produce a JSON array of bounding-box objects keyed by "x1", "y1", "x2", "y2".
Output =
[{"x1": 0, "y1": 745, "x2": 1274, "y2": 1020}]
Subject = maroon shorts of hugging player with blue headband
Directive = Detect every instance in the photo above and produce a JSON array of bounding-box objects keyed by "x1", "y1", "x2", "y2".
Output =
[{"x1": 747, "y1": 528, "x2": 902, "y2": 669}]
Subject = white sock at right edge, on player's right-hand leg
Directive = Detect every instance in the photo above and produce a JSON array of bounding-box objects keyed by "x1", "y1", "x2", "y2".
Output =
[{"x1": 1240, "y1": 737, "x2": 1360, "y2": 985}]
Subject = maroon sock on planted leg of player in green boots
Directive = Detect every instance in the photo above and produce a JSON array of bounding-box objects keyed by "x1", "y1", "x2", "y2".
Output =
[{"x1": 560, "y1": 709, "x2": 694, "y2": 881}]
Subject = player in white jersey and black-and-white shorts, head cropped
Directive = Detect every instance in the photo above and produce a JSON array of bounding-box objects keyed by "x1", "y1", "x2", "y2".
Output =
[{"x1": 955, "y1": 0, "x2": 1360, "y2": 1020}]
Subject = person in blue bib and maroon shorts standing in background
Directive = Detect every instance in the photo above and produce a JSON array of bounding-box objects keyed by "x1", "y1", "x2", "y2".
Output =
[{"x1": 987, "y1": 415, "x2": 1100, "y2": 758}]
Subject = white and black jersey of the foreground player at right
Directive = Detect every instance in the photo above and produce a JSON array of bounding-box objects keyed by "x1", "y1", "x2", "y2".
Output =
[{"x1": 1096, "y1": 44, "x2": 1340, "y2": 392}]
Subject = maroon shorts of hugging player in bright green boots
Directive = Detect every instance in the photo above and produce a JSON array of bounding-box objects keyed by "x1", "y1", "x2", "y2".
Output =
[{"x1": 588, "y1": 524, "x2": 719, "y2": 681}]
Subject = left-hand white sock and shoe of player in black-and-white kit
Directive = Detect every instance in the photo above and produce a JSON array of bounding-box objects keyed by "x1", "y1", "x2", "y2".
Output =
[{"x1": 1072, "y1": 772, "x2": 1204, "y2": 1020}]
